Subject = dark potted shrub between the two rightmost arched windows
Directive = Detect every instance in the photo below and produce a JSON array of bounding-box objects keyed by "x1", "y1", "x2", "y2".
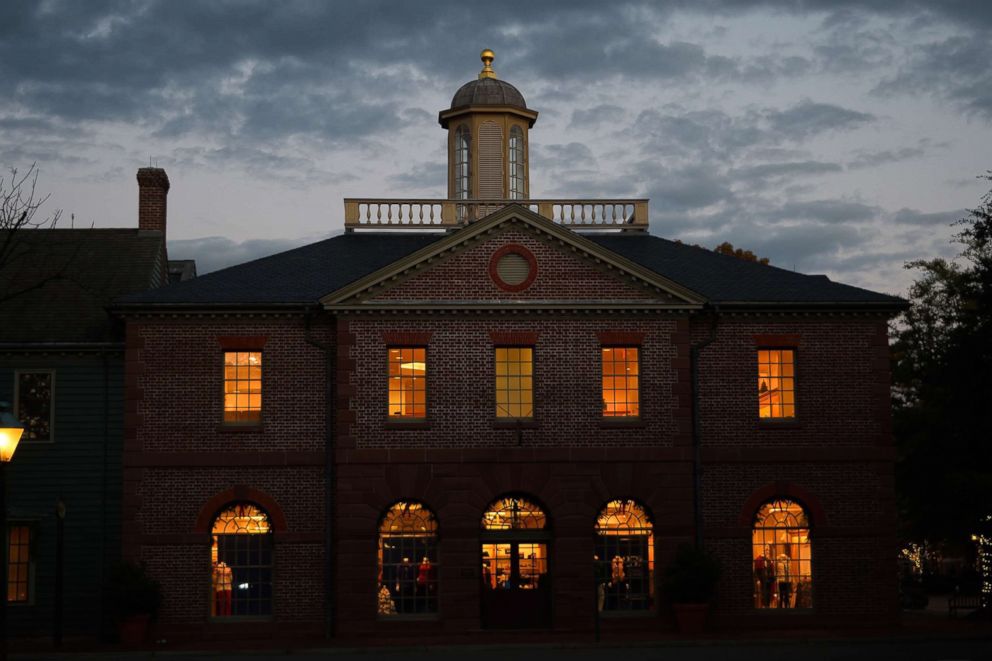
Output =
[{"x1": 662, "y1": 544, "x2": 720, "y2": 634}]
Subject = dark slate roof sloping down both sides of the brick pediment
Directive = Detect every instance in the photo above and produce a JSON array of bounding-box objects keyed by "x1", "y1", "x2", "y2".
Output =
[{"x1": 117, "y1": 227, "x2": 904, "y2": 308}]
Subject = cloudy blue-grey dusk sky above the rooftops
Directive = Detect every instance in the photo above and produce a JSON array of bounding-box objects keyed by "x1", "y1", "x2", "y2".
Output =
[{"x1": 0, "y1": 0, "x2": 992, "y2": 294}]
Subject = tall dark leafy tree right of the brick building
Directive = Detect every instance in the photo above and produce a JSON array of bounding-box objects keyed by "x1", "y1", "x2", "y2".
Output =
[{"x1": 893, "y1": 171, "x2": 992, "y2": 541}]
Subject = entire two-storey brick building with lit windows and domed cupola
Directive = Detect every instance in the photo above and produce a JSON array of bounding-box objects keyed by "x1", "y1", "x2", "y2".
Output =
[{"x1": 117, "y1": 52, "x2": 903, "y2": 640}]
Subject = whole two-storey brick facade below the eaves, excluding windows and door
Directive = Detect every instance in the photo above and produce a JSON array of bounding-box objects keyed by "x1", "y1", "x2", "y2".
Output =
[{"x1": 124, "y1": 298, "x2": 896, "y2": 638}]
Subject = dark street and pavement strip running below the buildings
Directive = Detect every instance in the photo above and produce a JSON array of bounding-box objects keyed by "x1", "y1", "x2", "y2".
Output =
[{"x1": 10, "y1": 607, "x2": 992, "y2": 661}]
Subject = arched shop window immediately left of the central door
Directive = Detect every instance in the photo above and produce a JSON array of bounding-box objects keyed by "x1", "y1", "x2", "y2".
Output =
[{"x1": 378, "y1": 501, "x2": 438, "y2": 616}]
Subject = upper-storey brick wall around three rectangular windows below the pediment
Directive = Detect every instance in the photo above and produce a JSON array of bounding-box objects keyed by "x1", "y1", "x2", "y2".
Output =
[{"x1": 347, "y1": 318, "x2": 688, "y2": 448}]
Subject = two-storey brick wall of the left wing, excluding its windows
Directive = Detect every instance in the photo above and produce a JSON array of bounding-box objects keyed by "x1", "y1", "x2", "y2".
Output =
[{"x1": 124, "y1": 315, "x2": 333, "y2": 637}]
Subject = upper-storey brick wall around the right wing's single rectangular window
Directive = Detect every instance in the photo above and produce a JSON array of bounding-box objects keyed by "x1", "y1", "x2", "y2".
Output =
[{"x1": 693, "y1": 316, "x2": 891, "y2": 448}]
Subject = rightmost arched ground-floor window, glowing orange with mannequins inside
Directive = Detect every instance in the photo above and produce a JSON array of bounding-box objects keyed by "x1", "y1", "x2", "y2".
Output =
[{"x1": 751, "y1": 498, "x2": 813, "y2": 608}]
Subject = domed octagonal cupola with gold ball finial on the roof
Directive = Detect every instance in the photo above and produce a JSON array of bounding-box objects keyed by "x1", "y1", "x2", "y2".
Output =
[{"x1": 438, "y1": 48, "x2": 537, "y2": 200}]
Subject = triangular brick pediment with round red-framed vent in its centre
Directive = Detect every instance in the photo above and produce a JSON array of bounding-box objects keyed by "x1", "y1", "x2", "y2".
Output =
[{"x1": 321, "y1": 205, "x2": 703, "y2": 310}]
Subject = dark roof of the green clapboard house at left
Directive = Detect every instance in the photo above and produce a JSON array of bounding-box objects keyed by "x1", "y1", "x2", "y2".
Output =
[{"x1": 0, "y1": 229, "x2": 164, "y2": 343}]
